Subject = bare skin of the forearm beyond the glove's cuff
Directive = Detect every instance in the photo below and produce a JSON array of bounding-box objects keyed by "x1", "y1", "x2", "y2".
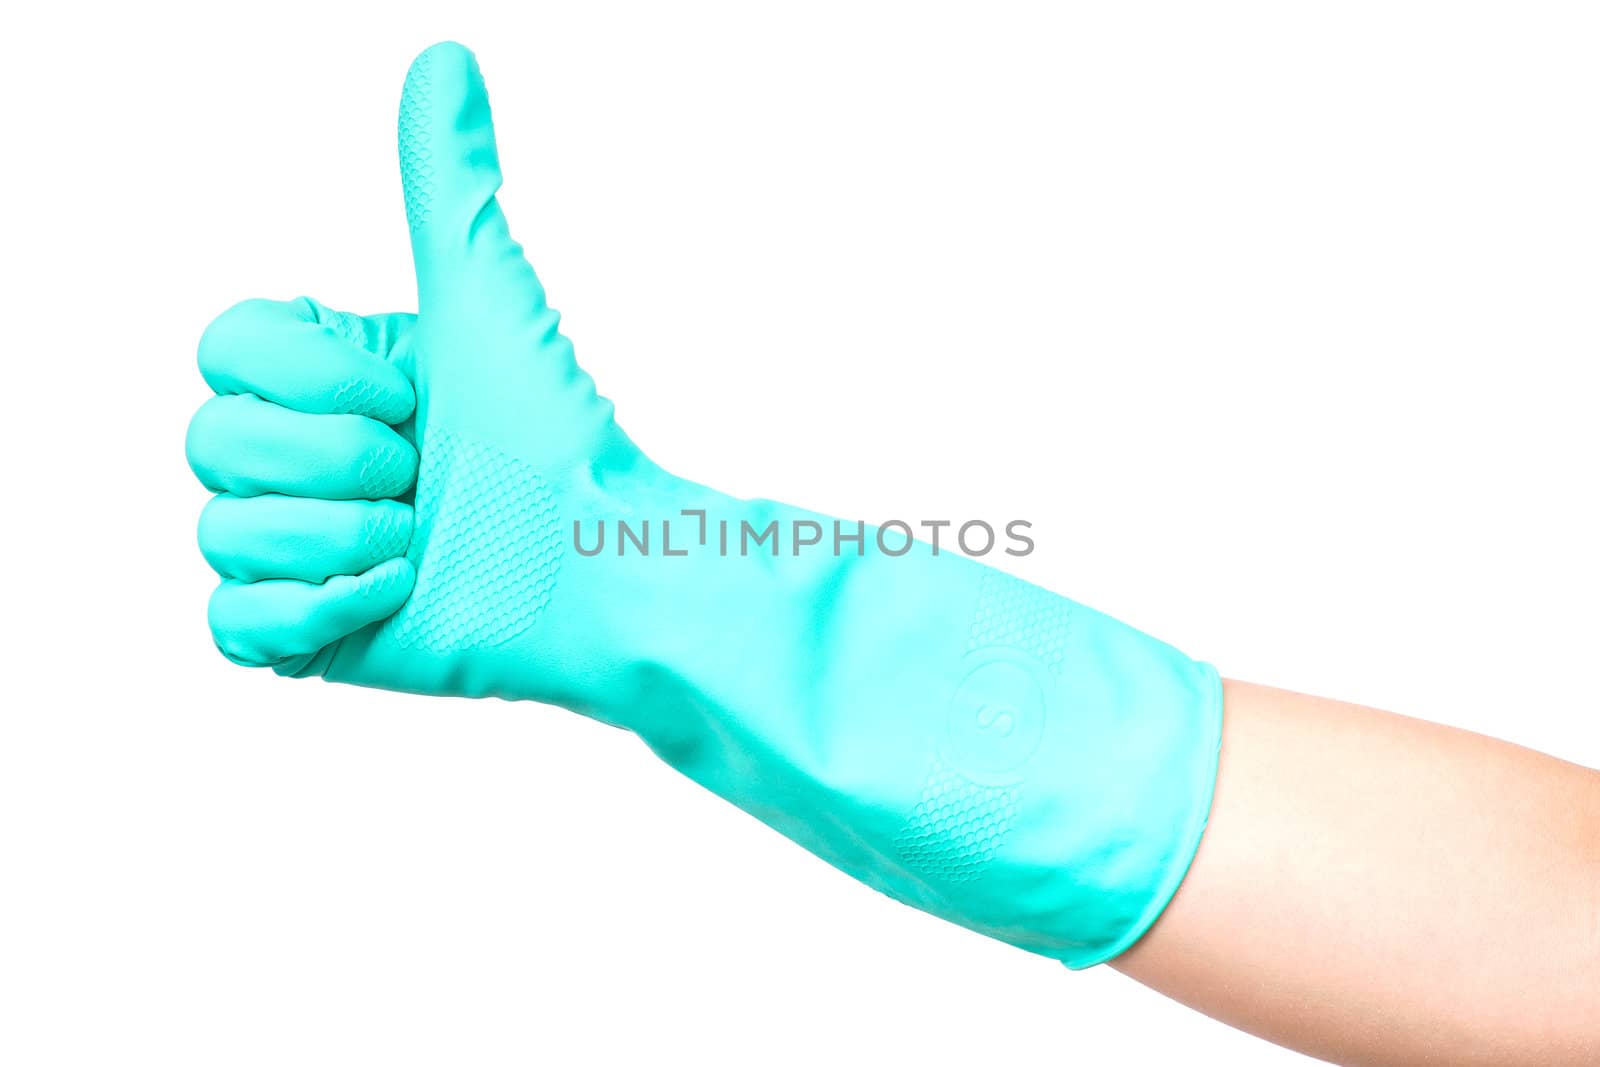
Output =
[{"x1": 1114, "y1": 681, "x2": 1600, "y2": 1067}]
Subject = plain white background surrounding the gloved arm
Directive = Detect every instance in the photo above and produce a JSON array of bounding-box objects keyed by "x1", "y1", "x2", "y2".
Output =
[{"x1": 0, "y1": 0, "x2": 1600, "y2": 1065}]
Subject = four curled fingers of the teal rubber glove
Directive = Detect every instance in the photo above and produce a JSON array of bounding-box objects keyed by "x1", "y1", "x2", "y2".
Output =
[{"x1": 187, "y1": 299, "x2": 418, "y2": 672}]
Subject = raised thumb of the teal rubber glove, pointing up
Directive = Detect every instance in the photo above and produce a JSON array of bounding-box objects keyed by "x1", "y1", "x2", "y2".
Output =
[{"x1": 398, "y1": 42, "x2": 544, "y2": 323}]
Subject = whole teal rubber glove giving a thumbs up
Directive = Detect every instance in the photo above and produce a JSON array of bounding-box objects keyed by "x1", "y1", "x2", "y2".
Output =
[{"x1": 187, "y1": 43, "x2": 1221, "y2": 966}]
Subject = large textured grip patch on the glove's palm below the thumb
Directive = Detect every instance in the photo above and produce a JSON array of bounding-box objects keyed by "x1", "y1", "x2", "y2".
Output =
[{"x1": 394, "y1": 426, "x2": 565, "y2": 653}]
